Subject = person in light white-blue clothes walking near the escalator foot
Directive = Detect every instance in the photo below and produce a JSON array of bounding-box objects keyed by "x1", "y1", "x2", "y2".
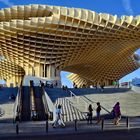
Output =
[{"x1": 52, "y1": 105, "x2": 65, "y2": 128}]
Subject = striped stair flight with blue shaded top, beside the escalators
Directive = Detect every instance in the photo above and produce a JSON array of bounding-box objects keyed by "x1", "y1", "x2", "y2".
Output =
[{"x1": 45, "y1": 88, "x2": 86, "y2": 122}]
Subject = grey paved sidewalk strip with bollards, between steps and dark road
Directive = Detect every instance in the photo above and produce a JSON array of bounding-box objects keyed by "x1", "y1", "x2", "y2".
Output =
[{"x1": 0, "y1": 118, "x2": 140, "y2": 136}]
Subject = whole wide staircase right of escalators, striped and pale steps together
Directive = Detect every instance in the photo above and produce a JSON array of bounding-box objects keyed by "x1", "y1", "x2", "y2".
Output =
[{"x1": 45, "y1": 87, "x2": 140, "y2": 121}]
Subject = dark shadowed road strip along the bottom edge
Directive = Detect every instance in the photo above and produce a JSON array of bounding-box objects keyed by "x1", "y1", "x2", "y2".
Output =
[{"x1": 0, "y1": 126, "x2": 140, "y2": 140}]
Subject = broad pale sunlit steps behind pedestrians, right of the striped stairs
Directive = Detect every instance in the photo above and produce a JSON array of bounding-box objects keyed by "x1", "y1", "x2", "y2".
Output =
[{"x1": 68, "y1": 88, "x2": 140, "y2": 117}]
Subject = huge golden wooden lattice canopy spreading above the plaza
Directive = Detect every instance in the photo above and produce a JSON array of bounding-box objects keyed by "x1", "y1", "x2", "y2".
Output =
[{"x1": 0, "y1": 5, "x2": 140, "y2": 81}]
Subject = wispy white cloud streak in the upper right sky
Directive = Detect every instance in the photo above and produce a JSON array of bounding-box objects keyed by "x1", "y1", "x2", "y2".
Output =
[{"x1": 123, "y1": 0, "x2": 134, "y2": 15}]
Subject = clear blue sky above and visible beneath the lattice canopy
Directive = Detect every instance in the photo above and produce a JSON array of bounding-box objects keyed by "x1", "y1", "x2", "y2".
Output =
[{"x1": 0, "y1": 0, "x2": 140, "y2": 86}]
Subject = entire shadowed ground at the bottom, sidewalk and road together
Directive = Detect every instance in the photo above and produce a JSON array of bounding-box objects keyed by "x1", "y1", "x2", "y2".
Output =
[{"x1": 0, "y1": 118, "x2": 140, "y2": 140}]
